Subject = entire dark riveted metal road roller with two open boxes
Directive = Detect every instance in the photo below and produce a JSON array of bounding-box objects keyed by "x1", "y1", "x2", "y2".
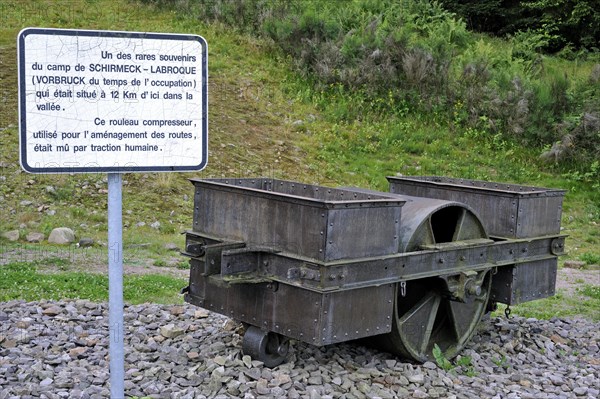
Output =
[{"x1": 183, "y1": 176, "x2": 565, "y2": 367}]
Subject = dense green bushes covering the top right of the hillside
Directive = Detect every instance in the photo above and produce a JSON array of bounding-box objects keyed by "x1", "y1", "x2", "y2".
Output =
[{"x1": 139, "y1": 0, "x2": 600, "y2": 176}]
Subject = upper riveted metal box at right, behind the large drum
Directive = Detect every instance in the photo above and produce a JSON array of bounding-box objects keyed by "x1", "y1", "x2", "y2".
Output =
[{"x1": 388, "y1": 176, "x2": 565, "y2": 238}]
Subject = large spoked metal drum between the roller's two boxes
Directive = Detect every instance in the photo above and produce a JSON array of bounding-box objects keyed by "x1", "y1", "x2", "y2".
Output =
[{"x1": 374, "y1": 196, "x2": 491, "y2": 362}]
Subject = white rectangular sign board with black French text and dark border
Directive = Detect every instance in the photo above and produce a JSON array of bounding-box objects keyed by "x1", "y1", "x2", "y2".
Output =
[{"x1": 18, "y1": 28, "x2": 208, "y2": 173}]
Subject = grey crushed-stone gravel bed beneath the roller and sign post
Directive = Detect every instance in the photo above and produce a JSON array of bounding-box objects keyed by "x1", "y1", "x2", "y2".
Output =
[{"x1": 0, "y1": 301, "x2": 600, "y2": 399}]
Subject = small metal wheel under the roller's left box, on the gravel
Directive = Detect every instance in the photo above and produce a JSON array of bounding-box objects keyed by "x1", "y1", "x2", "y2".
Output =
[{"x1": 242, "y1": 326, "x2": 290, "y2": 367}]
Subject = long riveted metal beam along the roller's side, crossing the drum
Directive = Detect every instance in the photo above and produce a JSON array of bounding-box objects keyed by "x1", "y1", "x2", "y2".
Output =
[{"x1": 190, "y1": 236, "x2": 565, "y2": 292}]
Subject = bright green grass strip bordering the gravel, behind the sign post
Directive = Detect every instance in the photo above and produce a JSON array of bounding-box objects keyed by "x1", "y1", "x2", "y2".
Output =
[{"x1": 0, "y1": 260, "x2": 186, "y2": 304}]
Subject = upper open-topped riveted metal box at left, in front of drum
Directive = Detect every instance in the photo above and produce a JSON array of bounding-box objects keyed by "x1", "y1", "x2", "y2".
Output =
[{"x1": 192, "y1": 179, "x2": 404, "y2": 260}]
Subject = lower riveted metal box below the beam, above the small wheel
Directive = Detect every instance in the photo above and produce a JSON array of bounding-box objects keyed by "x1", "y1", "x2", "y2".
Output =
[{"x1": 185, "y1": 260, "x2": 394, "y2": 345}]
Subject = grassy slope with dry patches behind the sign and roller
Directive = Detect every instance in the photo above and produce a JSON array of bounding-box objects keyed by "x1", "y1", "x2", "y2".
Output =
[{"x1": 0, "y1": 0, "x2": 600, "y2": 316}]
